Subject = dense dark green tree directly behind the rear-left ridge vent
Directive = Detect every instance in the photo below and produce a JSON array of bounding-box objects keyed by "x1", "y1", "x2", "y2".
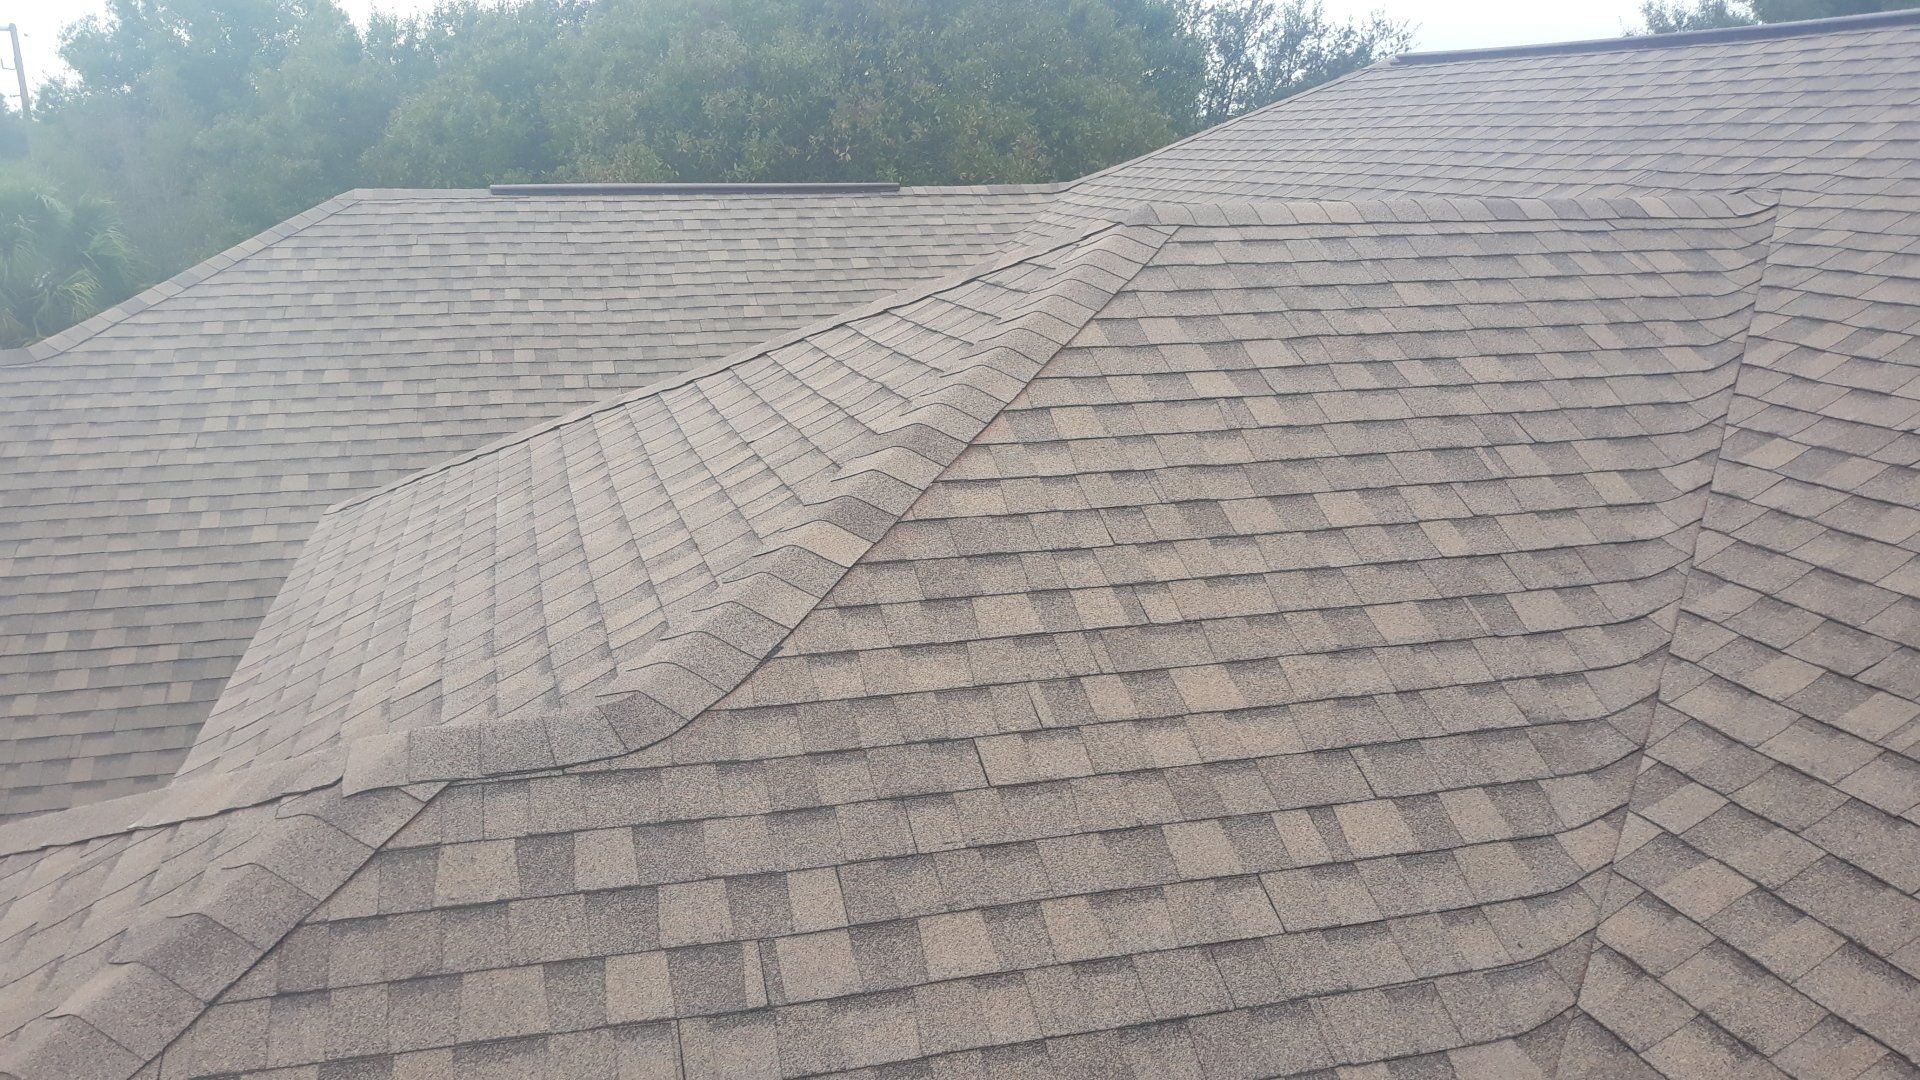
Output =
[{"x1": 543, "y1": 0, "x2": 1202, "y2": 183}]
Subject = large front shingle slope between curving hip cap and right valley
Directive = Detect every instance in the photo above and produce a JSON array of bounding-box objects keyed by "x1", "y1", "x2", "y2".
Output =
[{"x1": 15, "y1": 200, "x2": 1772, "y2": 1076}]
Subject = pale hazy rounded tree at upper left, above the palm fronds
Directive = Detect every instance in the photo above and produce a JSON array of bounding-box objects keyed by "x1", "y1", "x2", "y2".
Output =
[{"x1": 35, "y1": 0, "x2": 392, "y2": 271}]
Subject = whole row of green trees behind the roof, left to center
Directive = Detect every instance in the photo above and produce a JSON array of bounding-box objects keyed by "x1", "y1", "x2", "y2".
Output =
[{"x1": 0, "y1": 0, "x2": 1411, "y2": 340}]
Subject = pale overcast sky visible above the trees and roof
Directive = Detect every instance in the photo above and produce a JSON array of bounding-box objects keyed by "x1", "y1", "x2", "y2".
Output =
[{"x1": 0, "y1": 0, "x2": 1640, "y2": 107}]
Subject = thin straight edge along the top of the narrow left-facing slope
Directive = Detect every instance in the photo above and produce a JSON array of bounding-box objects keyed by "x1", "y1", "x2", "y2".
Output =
[{"x1": 321, "y1": 209, "x2": 1121, "y2": 519}]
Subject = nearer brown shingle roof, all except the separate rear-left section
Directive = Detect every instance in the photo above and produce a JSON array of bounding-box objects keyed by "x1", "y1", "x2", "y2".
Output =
[{"x1": 0, "y1": 17, "x2": 1920, "y2": 1080}]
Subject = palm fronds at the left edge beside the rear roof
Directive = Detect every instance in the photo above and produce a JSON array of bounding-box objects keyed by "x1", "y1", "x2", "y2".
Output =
[{"x1": 0, "y1": 184, "x2": 134, "y2": 348}]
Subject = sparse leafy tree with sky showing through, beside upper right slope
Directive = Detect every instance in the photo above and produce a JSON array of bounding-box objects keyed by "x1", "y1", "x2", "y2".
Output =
[{"x1": 1183, "y1": 0, "x2": 1413, "y2": 127}]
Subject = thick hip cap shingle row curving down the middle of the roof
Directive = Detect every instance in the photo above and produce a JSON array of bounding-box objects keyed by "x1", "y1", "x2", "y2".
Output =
[{"x1": 342, "y1": 223, "x2": 1175, "y2": 794}]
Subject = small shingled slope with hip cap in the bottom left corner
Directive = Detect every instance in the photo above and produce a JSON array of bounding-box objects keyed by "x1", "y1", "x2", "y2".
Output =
[{"x1": 0, "y1": 776, "x2": 432, "y2": 1080}]
